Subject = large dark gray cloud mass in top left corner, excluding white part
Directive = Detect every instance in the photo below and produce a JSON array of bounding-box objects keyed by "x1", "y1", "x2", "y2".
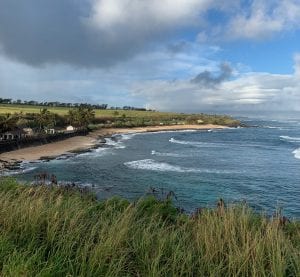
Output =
[{"x1": 0, "y1": 0, "x2": 151, "y2": 67}]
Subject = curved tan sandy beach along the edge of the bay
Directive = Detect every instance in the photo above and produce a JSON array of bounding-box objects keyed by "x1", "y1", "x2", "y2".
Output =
[{"x1": 0, "y1": 124, "x2": 229, "y2": 171}]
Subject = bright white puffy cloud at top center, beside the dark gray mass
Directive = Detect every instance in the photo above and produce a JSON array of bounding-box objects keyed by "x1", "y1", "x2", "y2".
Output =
[{"x1": 91, "y1": 0, "x2": 215, "y2": 32}]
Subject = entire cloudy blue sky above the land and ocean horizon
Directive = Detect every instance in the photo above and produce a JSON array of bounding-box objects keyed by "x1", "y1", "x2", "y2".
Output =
[{"x1": 0, "y1": 0, "x2": 300, "y2": 114}]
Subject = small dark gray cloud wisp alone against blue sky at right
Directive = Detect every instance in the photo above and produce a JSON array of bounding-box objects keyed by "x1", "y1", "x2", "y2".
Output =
[{"x1": 191, "y1": 63, "x2": 232, "y2": 87}]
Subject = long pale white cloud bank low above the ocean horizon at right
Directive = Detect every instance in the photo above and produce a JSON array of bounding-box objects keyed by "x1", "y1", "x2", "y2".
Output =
[{"x1": 133, "y1": 55, "x2": 300, "y2": 112}]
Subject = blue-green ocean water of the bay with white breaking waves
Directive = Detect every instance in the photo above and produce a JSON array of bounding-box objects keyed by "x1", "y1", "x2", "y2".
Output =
[{"x1": 9, "y1": 120, "x2": 300, "y2": 218}]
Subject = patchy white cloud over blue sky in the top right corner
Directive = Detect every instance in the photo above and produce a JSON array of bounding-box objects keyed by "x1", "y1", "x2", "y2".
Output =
[{"x1": 197, "y1": 0, "x2": 300, "y2": 42}]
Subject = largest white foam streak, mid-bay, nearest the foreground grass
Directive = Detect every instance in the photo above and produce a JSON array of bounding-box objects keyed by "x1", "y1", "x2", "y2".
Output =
[{"x1": 124, "y1": 159, "x2": 237, "y2": 174}]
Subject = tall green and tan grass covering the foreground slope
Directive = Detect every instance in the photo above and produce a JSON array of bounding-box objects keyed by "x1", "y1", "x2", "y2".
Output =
[{"x1": 0, "y1": 179, "x2": 300, "y2": 276}]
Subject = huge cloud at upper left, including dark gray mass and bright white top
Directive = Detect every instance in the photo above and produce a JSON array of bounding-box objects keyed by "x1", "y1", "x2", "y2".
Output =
[{"x1": 0, "y1": 0, "x2": 213, "y2": 67}]
